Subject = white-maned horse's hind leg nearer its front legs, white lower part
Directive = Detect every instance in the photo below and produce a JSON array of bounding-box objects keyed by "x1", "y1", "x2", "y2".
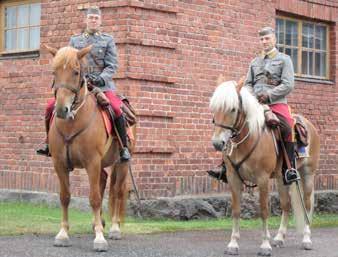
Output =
[{"x1": 272, "y1": 178, "x2": 291, "y2": 247}]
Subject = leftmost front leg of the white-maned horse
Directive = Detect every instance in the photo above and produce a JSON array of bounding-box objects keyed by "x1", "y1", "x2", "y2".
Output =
[{"x1": 225, "y1": 174, "x2": 242, "y2": 255}]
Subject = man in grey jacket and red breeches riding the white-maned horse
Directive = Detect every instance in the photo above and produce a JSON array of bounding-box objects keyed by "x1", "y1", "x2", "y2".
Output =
[{"x1": 207, "y1": 27, "x2": 299, "y2": 185}]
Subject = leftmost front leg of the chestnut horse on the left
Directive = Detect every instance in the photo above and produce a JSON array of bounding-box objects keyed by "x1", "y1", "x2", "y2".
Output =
[{"x1": 54, "y1": 165, "x2": 71, "y2": 247}]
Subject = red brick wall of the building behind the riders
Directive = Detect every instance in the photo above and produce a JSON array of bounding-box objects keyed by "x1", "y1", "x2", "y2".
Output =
[{"x1": 0, "y1": 0, "x2": 338, "y2": 198}]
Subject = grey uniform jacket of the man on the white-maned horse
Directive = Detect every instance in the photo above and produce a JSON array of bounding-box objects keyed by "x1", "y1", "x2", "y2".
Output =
[{"x1": 245, "y1": 49, "x2": 294, "y2": 104}]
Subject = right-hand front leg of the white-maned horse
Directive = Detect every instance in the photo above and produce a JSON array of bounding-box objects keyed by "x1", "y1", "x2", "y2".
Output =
[{"x1": 258, "y1": 181, "x2": 272, "y2": 256}]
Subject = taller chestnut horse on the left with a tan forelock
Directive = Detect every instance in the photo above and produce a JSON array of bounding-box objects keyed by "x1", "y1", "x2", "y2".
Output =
[{"x1": 46, "y1": 46, "x2": 136, "y2": 251}]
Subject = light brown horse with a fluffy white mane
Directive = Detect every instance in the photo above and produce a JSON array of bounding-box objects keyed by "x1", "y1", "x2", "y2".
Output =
[{"x1": 210, "y1": 79, "x2": 319, "y2": 256}]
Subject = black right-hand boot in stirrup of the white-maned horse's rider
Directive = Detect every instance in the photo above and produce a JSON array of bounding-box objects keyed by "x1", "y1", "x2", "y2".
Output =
[{"x1": 282, "y1": 142, "x2": 300, "y2": 185}]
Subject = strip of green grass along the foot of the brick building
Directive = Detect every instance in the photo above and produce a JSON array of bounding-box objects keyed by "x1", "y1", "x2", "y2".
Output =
[{"x1": 0, "y1": 202, "x2": 338, "y2": 235}]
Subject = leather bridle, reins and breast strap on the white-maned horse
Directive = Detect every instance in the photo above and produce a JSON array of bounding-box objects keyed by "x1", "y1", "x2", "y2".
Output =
[{"x1": 213, "y1": 94, "x2": 261, "y2": 188}]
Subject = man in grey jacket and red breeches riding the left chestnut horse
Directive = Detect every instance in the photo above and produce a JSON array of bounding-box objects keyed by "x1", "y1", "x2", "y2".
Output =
[{"x1": 37, "y1": 7, "x2": 131, "y2": 161}]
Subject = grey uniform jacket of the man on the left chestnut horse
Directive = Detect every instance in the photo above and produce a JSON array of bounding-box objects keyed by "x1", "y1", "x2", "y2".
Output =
[{"x1": 69, "y1": 32, "x2": 118, "y2": 91}]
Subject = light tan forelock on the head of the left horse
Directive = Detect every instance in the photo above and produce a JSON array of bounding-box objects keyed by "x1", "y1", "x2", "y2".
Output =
[{"x1": 52, "y1": 46, "x2": 84, "y2": 70}]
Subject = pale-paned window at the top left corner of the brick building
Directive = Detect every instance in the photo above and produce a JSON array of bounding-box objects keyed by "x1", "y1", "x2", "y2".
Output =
[{"x1": 0, "y1": 1, "x2": 41, "y2": 53}]
